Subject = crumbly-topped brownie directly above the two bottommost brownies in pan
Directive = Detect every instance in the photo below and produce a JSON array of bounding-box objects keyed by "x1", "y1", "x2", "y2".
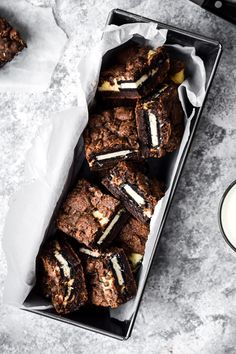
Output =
[{"x1": 57, "y1": 179, "x2": 127, "y2": 248}]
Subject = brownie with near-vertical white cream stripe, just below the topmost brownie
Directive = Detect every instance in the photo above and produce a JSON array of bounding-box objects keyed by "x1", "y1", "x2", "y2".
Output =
[{"x1": 136, "y1": 83, "x2": 184, "y2": 158}]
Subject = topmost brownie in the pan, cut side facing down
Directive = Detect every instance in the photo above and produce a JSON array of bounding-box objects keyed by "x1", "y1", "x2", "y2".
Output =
[{"x1": 98, "y1": 45, "x2": 170, "y2": 104}]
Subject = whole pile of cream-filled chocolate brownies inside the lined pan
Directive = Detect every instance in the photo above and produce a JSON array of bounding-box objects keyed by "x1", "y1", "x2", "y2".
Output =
[{"x1": 37, "y1": 44, "x2": 184, "y2": 314}]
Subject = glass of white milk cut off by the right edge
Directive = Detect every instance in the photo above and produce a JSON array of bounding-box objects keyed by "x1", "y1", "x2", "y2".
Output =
[{"x1": 219, "y1": 180, "x2": 236, "y2": 251}]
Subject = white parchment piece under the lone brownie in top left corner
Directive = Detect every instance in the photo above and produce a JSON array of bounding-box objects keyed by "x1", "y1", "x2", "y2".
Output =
[{"x1": 0, "y1": 0, "x2": 67, "y2": 92}]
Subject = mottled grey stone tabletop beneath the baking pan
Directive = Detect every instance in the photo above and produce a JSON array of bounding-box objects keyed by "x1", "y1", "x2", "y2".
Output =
[{"x1": 0, "y1": 0, "x2": 236, "y2": 354}]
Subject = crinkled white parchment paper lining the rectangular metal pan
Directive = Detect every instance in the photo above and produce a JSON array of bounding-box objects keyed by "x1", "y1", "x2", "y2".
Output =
[{"x1": 3, "y1": 23, "x2": 205, "y2": 320}]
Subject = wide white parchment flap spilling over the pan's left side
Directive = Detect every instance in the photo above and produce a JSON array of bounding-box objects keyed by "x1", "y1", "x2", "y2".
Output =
[{"x1": 3, "y1": 81, "x2": 88, "y2": 306}]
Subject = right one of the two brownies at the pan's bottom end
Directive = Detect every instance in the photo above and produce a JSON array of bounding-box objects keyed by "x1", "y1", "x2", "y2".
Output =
[{"x1": 85, "y1": 248, "x2": 137, "y2": 308}]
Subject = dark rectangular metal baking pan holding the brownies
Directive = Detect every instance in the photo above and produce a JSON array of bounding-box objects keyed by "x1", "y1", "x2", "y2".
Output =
[{"x1": 23, "y1": 9, "x2": 222, "y2": 340}]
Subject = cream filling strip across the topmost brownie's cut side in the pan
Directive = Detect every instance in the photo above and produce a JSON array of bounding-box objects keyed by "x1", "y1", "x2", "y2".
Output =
[{"x1": 98, "y1": 68, "x2": 158, "y2": 91}]
